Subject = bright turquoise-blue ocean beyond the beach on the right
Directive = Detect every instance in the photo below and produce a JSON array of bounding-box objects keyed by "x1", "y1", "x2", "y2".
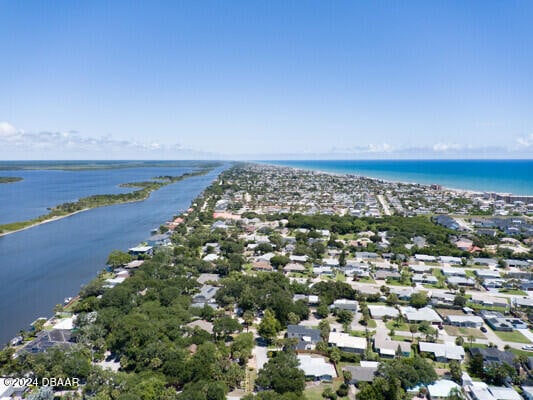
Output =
[{"x1": 260, "y1": 160, "x2": 533, "y2": 195}]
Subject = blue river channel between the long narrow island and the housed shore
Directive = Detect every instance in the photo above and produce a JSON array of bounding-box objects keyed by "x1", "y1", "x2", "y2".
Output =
[{"x1": 0, "y1": 164, "x2": 229, "y2": 344}]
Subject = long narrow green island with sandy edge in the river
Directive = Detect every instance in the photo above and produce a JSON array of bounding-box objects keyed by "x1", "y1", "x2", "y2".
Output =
[{"x1": 0, "y1": 168, "x2": 211, "y2": 236}]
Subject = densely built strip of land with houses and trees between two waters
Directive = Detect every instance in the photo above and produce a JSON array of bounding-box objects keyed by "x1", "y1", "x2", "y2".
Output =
[{"x1": 0, "y1": 164, "x2": 533, "y2": 400}]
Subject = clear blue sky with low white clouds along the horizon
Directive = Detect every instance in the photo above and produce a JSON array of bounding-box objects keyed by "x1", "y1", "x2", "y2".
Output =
[{"x1": 0, "y1": 0, "x2": 533, "y2": 159}]
